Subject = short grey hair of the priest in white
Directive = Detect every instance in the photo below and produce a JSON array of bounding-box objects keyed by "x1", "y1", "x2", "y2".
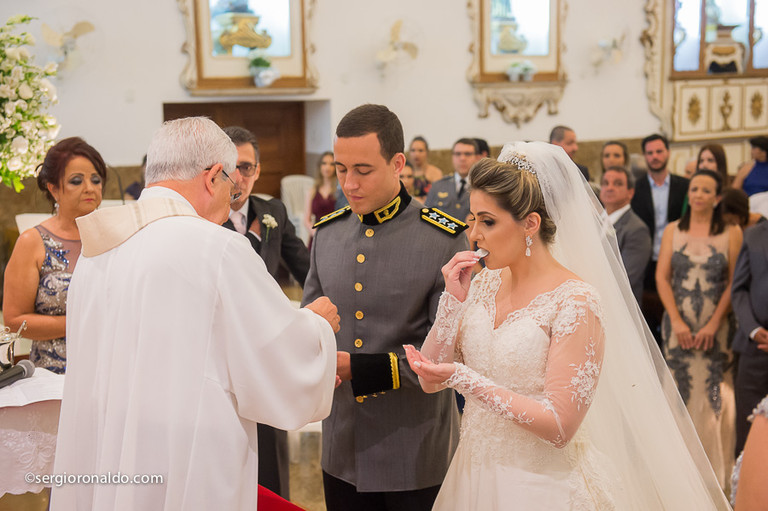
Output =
[{"x1": 146, "y1": 117, "x2": 237, "y2": 184}]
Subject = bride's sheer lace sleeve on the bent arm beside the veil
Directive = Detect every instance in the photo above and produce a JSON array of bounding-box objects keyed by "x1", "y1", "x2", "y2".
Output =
[{"x1": 443, "y1": 294, "x2": 605, "y2": 447}]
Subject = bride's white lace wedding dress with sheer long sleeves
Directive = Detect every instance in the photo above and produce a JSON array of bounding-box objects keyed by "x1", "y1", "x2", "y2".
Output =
[{"x1": 422, "y1": 269, "x2": 615, "y2": 511}]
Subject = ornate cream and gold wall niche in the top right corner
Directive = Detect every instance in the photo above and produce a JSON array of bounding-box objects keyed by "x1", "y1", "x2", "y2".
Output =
[{"x1": 641, "y1": 0, "x2": 768, "y2": 142}]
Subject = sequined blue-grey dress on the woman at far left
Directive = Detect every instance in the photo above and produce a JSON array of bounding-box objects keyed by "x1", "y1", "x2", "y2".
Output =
[{"x1": 29, "y1": 225, "x2": 81, "y2": 374}]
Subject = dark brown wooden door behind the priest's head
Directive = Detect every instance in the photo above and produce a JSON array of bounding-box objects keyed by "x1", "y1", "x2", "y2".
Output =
[{"x1": 163, "y1": 101, "x2": 306, "y2": 198}]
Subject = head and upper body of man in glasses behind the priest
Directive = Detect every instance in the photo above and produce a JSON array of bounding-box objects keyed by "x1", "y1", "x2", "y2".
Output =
[{"x1": 224, "y1": 126, "x2": 309, "y2": 290}]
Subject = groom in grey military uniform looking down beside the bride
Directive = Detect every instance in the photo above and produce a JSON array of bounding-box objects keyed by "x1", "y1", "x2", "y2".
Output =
[{"x1": 303, "y1": 105, "x2": 468, "y2": 511}]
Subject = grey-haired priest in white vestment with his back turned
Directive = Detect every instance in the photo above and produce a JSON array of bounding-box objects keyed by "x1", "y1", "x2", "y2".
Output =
[{"x1": 51, "y1": 118, "x2": 338, "y2": 511}]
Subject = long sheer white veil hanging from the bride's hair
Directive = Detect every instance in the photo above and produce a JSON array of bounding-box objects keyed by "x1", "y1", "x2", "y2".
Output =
[{"x1": 499, "y1": 142, "x2": 730, "y2": 511}]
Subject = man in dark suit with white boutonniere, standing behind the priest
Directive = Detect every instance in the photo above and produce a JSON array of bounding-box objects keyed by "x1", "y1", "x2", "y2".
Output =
[{"x1": 219, "y1": 126, "x2": 309, "y2": 499}]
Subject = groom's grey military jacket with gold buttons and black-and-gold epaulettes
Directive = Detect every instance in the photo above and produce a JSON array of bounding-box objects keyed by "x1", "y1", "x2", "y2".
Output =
[{"x1": 303, "y1": 190, "x2": 468, "y2": 492}]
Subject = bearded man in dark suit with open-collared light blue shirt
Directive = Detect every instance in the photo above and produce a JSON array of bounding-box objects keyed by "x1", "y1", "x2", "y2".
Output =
[{"x1": 631, "y1": 134, "x2": 688, "y2": 352}]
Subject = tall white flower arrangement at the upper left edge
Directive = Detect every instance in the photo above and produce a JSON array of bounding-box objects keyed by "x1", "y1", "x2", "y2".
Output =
[{"x1": 0, "y1": 15, "x2": 60, "y2": 192}]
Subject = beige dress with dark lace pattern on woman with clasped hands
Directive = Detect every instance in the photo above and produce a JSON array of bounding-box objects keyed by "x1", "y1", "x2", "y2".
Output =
[{"x1": 662, "y1": 226, "x2": 736, "y2": 489}]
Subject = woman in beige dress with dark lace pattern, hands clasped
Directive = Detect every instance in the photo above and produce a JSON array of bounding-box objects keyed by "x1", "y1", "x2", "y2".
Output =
[{"x1": 656, "y1": 170, "x2": 742, "y2": 489}]
